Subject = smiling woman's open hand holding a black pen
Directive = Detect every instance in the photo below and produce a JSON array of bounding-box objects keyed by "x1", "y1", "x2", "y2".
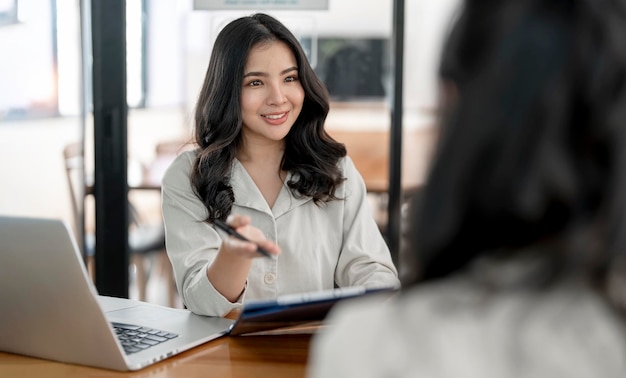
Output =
[{"x1": 222, "y1": 214, "x2": 281, "y2": 259}]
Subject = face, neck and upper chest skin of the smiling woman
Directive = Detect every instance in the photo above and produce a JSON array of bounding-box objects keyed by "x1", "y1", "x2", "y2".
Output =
[{"x1": 236, "y1": 41, "x2": 304, "y2": 211}]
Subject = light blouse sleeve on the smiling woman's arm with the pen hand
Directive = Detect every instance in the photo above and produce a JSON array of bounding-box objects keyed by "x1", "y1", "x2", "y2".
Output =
[{"x1": 161, "y1": 151, "x2": 245, "y2": 316}]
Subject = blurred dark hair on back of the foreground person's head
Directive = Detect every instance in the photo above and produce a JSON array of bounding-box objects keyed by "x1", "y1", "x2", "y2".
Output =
[{"x1": 414, "y1": 0, "x2": 626, "y2": 296}]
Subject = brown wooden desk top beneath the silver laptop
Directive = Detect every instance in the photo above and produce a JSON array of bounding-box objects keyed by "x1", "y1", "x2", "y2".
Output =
[{"x1": 0, "y1": 334, "x2": 312, "y2": 378}]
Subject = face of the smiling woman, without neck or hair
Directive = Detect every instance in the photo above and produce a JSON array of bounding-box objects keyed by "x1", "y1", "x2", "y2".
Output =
[{"x1": 241, "y1": 41, "x2": 304, "y2": 145}]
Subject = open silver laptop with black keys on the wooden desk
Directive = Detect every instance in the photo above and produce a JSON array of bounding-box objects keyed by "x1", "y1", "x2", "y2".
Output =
[{"x1": 0, "y1": 216, "x2": 233, "y2": 370}]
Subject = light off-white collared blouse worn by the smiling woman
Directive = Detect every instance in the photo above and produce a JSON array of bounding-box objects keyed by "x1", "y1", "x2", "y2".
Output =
[{"x1": 162, "y1": 151, "x2": 400, "y2": 316}]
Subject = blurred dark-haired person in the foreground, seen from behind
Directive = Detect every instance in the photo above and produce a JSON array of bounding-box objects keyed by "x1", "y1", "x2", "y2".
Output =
[{"x1": 309, "y1": 0, "x2": 626, "y2": 378}]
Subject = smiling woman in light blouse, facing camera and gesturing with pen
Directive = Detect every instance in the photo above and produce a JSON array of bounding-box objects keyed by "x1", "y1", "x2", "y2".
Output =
[{"x1": 162, "y1": 14, "x2": 399, "y2": 316}]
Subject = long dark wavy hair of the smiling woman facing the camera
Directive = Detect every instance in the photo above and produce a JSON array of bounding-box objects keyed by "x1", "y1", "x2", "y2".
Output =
[{"x1": 191, "y1": 13, "x2": 346, "y2": 222}]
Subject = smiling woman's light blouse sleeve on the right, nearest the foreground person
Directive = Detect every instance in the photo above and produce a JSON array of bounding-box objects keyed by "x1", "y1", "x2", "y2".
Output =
[{"x1": 335, "y1": 157, "x2": 400, "y2": 287}]
